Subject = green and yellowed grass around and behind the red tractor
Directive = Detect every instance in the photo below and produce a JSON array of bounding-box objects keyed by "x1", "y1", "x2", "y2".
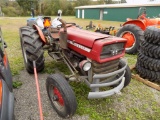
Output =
[{"x1": 0, "y1": 16, "x2": 160, "y2": 120}]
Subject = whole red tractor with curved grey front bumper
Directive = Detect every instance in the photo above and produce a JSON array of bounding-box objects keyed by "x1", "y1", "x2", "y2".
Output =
[{"x1": 20, "y1": 11, "x2": 131, "y2": 118}]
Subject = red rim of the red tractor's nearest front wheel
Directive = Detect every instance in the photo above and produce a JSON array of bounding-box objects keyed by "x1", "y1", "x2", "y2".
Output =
[{"x1": 49, "y1": 85, "x2": 65, "y2": 111}]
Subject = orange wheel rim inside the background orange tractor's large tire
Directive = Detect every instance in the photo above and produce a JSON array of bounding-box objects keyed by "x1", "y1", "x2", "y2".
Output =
[{"x1": 120, "y1": 31, "x2": 136, "y2": 50}]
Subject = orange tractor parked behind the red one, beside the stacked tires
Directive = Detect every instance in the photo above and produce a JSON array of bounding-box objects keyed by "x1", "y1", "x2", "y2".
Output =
[{"x1": 117, "y1": 7, "x2": 160, "y2": 54}]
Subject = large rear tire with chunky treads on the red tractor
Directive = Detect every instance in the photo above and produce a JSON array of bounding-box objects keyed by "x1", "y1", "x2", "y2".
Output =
[{"x1": 20, "y1": 26, "x2": 44, "y2": 73}]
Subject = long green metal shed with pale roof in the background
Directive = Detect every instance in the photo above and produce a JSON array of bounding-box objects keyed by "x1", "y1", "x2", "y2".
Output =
[{"x1": 75, "y1": 3, "x2": 160, "y2": 22}]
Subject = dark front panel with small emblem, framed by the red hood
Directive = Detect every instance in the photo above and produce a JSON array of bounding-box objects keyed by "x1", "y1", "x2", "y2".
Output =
[{"x1": 100, "y1": 43, "x2": 125, "y2": 59}]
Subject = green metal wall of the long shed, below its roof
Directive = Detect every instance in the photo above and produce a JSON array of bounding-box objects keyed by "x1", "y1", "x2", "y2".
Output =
[{"x1": 76, "y1": 6, "x2": 160, "y2": 22}]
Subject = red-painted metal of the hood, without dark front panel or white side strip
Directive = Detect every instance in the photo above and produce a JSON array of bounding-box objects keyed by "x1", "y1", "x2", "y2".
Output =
[{"x1": 67, "y1": 28, "x2": 127, "y2": 63}]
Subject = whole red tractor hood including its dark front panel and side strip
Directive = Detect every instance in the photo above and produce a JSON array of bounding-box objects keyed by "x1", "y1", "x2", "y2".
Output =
[{"x1": 67, "y1": 27, "x2": 127, "y2": 63}]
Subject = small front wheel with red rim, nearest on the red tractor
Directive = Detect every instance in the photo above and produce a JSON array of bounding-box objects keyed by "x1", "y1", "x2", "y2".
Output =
[{"x1": 46, "y1": 74, "x2": 77, "y2": 118}]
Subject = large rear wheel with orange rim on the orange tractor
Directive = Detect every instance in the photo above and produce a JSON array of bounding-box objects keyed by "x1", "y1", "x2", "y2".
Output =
[{"x1": 116, "y1": 24, "x2": 144, "y2": 54}]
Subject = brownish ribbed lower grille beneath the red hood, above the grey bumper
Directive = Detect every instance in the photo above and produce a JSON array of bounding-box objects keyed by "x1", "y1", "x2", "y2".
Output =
[{"x1": 92, "y1": 59, "x2": 119, "y2": 74}]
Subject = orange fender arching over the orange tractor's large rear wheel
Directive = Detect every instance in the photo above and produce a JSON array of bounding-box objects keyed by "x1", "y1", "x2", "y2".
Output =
[{"x1": 123, "y1": 20, "x2": 146, "y2": 31}]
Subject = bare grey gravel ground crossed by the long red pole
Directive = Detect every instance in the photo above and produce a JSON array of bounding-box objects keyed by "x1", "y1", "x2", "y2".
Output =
[{"x1": 13, "y1": 70, "x2": 89, "y2": 120}]
